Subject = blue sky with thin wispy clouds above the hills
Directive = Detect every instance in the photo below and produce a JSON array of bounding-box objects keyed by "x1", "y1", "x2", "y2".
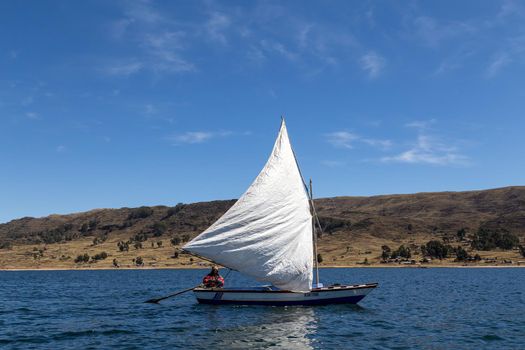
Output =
[{"x1": 0, "y1": 1, "x2": 525, "y2": 222}]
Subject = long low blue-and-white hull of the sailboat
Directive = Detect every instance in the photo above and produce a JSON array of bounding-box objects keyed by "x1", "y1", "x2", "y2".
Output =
[{"x1": 193, "y1": 283, "x2": 377, "y2": 306}]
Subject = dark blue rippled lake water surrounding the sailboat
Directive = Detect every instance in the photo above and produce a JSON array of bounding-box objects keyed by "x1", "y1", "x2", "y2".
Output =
[{"x1": 0, "y1": 268, "x2": 525, "y2": 349}]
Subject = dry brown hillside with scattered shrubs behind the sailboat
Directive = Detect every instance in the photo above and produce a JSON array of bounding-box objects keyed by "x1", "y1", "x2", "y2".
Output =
[{"x1": 0, "y1": 187, "x2": 525, "y2": 268}]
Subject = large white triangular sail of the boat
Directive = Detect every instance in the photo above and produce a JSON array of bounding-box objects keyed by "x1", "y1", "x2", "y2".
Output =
[{"x1": 184, "y1": 121, "x2": 313, "y2": 291}]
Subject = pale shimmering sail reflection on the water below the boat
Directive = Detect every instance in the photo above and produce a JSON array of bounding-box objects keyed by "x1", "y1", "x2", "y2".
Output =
[{"x1": 203, "y1": 306, "x2": 317, "y2": 349}]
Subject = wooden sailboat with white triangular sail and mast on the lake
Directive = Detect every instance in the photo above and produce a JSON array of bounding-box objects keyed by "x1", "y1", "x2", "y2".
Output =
[{"x1": 182, "y1": 119, "x2": 378, "y2": 305}]
